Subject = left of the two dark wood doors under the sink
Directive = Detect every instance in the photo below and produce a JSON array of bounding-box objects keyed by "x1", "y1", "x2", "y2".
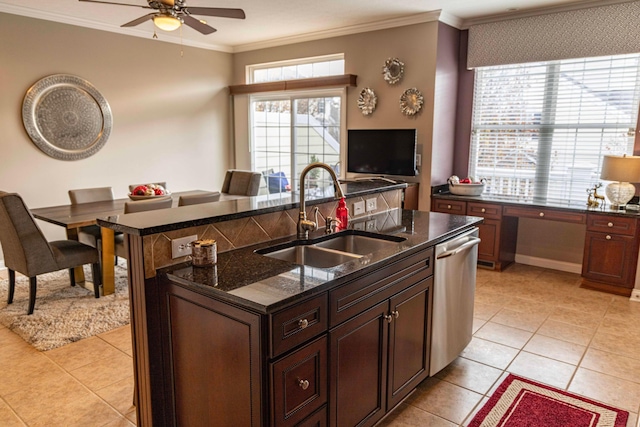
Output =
[{"x1": 329, "y1": 300, "x2": 389, "y2": 427}]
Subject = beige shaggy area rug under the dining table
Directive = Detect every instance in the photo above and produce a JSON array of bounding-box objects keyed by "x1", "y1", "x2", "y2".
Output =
[{"x1": 0, "y1": 260, "x2": 129, "y2": 351}]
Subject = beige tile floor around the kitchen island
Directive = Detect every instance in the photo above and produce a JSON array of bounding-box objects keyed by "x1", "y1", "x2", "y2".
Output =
[{"x1": 0, "y1": 264, "x2": 640, "y2": 427}]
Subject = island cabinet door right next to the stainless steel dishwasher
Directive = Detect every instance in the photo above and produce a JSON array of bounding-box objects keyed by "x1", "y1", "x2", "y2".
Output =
[{"x1": 387, "y1": 277, "x2": 433, "y2": 411}]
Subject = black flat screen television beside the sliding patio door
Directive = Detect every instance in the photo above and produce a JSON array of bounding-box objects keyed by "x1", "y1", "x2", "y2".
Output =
[{"x1": 347, "y1": 129, "x2": 418, "y2": 176}]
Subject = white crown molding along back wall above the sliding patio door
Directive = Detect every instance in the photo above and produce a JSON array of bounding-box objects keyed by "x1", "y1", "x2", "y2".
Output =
[{"x1": 233, "y1": 10, "x2": 448, "y2": 53}]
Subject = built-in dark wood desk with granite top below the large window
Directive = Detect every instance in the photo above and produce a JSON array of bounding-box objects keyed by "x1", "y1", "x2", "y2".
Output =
[{"x1": 431, "y1": 193, "x2": 640, "y2": 296}]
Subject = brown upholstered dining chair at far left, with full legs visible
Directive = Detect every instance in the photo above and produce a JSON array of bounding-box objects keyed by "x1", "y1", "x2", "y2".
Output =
[{"x1": 0, "y1": 191, "x2": 102, "y2": 314}]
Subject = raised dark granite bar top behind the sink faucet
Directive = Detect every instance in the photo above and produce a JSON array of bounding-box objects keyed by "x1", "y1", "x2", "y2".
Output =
[{"x1": 98, "y1": 180, "x2": 407, "y2": 236}]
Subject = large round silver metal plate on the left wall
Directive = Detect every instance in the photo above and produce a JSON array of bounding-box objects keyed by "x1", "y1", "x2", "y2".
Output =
[{"x1": 22, "y1": 74, "x2": 113, "y2": 160}]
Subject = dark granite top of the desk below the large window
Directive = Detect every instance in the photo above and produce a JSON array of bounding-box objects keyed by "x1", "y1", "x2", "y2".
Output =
[{"x1": 431, "y1": 190, "x2": 640, "y2": 216}]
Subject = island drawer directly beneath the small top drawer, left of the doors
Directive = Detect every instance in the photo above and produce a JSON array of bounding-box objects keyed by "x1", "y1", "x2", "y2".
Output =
[{"x1": 271, "y1": 335, "x2": 329, "y2": 427}]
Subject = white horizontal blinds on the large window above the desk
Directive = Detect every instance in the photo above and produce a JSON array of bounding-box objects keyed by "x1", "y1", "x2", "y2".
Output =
[{"x1": 469, "y1": 54, "x2": 640, "y2": 202}]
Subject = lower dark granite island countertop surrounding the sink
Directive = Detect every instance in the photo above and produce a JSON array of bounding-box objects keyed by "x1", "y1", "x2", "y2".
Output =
[{"x1": 159, "y1": 210, "x2": 482, "y2": 313}]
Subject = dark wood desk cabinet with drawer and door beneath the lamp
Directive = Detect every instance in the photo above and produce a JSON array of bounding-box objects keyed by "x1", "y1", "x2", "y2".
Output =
[{"x1": 582, "y1": 214, "x2": 638, "y2": 296}]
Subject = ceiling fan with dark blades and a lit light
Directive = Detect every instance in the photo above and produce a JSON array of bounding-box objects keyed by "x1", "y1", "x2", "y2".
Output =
[{"x1": 79, "y1": 0, "x2": 245, "y2": 34}]
